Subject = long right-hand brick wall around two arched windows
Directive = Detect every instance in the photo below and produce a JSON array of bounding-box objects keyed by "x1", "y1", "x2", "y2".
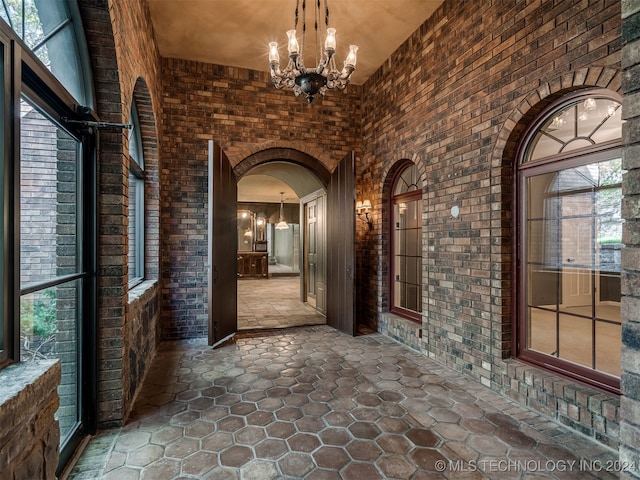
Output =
[{"x1": 357, "y1": 0, "x2": 621, "y2": 446}]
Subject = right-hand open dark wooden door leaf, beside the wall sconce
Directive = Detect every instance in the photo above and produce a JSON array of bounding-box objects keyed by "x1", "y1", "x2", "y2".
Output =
[{"x1": 326, "y1": 152, "x2": 356, "y2": 335}]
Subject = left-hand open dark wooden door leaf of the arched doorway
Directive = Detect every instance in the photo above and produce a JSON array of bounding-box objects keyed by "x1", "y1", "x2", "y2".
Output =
[{"x1": 208, "y1": 141, "x2": 238, "y2": 346}]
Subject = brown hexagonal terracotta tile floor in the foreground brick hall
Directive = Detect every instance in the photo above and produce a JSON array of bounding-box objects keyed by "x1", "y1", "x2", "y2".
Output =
[{"x1": 69, "y1": 325, "x2": 618, "y2": 480}]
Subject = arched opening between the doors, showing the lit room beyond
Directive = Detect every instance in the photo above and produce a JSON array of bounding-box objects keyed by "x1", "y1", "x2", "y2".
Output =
[{"x1": 237, "y1": 154, "x2": 336, "y2": 331}]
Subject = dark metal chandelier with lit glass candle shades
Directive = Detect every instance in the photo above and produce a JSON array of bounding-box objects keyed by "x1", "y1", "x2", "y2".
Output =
[{"x1": 269, "y1": 0, "x2": 358, "y2": 103}]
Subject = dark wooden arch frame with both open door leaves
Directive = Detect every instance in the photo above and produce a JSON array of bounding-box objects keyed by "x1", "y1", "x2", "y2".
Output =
[{"x1": 208, "y1": 141, "x2": 355, "y2": 345}]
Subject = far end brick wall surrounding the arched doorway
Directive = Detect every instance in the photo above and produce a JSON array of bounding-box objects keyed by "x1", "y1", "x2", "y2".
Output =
[{"x1": 161, "y1": 58, "x2": 360, "y2": 339}]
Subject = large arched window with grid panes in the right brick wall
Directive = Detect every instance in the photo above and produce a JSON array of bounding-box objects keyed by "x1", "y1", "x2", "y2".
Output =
[{"x1": 516, "y1": 91, "x2": 623, "y2": 391}]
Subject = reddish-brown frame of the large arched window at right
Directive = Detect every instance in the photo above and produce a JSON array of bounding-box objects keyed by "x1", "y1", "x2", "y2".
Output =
[{"x1": 512, "y1": 89, "x2": 622, "y2": 394}]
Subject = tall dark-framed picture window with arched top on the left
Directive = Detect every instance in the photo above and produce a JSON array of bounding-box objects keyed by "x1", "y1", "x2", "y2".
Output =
[{"x1": 0, "y1": 0, "x2": 97, "y2": 473}]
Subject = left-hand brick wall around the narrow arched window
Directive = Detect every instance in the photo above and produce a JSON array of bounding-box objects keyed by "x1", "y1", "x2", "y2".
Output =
[{"x1": 78, "y1": 0, "x2": 161, "y2": 426}]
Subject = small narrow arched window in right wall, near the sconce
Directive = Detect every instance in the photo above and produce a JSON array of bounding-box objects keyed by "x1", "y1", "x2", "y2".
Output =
[{"x1": 389, "y1": 162, "x2": 422, "y2": 322}]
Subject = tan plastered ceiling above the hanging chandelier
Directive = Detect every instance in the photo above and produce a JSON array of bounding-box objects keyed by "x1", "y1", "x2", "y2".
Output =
[{"x1": 149, "y1": 0, "x2": 443, "y2": 85}]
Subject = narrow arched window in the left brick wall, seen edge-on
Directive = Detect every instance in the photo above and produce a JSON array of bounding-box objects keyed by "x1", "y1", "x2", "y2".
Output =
[{"x1": 129, "y1": 100, "x2": 144, "y2": 288}]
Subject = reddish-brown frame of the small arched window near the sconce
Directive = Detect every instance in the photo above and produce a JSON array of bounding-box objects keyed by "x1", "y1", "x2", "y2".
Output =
[{"x1": 389, "y1": 160, "x2": 423, "y2": 324}]
